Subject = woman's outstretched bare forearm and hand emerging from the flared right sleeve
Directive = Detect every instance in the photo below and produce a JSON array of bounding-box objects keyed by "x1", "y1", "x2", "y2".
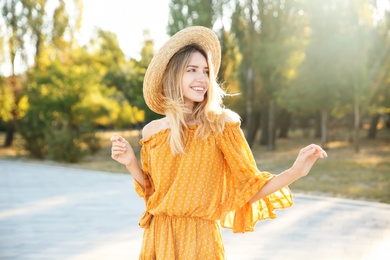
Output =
[{"x1": 249, "y1": 144, "x2": 328, "y2": 203}]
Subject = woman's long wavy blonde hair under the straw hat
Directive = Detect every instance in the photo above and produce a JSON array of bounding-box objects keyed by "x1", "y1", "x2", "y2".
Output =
[{"x1": 162, "y1": 44, "x2": 238, "y2": 155}]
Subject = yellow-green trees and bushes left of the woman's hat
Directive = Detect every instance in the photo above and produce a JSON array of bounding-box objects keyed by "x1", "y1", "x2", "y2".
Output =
[{"x1": 0, "y1": 0, "x2": 149, "y2": 162}]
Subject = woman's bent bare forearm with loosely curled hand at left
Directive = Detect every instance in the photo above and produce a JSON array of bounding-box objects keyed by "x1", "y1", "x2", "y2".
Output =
[{"x1": 110, "y1": 135, "x2": 145, "y2": 188}]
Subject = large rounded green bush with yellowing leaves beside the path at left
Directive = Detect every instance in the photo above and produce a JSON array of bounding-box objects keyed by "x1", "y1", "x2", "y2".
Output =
[{"x1": 19, "y1": 58, "x2": 108, "y2": 162}]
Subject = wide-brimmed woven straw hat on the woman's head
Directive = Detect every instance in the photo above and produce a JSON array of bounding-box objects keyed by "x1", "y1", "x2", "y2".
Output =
[{"x1": 143, "y1": 26, "x2": 221, "y2": 115}]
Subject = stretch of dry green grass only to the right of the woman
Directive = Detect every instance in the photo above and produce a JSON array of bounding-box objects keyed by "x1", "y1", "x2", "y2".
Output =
[{"x1": 253, "y1": 130, "x2": 390, "y2": 203}]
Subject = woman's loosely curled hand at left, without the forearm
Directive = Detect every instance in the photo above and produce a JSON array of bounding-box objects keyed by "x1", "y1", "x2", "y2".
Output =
[{"x1": 110, "y1": 135, "x2": 137, "y2": 167}]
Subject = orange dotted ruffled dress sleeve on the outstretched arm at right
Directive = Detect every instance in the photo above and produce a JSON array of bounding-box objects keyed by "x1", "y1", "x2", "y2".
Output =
[{"x1": 216, "y1": 122, "x2": 292, "y2": 233}]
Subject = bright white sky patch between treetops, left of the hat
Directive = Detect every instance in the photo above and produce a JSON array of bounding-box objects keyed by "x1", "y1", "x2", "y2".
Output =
[{"x1": 80, "y1": 0, "x2": 169, "y2": 58}]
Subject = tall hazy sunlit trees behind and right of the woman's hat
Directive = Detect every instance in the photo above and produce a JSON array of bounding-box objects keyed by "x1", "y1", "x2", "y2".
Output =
[{"x1": 168, "y1": 0, "x2": 390, "y2": 152}]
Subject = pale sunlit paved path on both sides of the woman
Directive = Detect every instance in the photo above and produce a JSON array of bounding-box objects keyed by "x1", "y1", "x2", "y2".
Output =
[{"x1": 0, "y1": 160, "x2": 390, "y2": 260}]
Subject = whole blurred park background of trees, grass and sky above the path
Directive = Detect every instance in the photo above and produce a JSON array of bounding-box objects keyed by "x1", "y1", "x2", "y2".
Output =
[{"x1": 0, "y1": 0, "x2": 390, "y2": 203}]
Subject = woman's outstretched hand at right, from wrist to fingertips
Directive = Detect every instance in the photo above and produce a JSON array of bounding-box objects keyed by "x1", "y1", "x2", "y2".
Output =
[{"x1": 291, "y1": 144, "x2": 328, "y2": 177}]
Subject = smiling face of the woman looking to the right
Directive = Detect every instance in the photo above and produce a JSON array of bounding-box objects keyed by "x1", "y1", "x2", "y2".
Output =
[{"x1": 182, "y1": 51, "x2": 209, "y2": 109}]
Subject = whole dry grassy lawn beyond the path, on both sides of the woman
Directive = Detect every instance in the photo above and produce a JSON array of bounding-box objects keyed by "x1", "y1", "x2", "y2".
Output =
[{"x1": 0, "y1": 127, "x2": 390, "y2": 203}]
